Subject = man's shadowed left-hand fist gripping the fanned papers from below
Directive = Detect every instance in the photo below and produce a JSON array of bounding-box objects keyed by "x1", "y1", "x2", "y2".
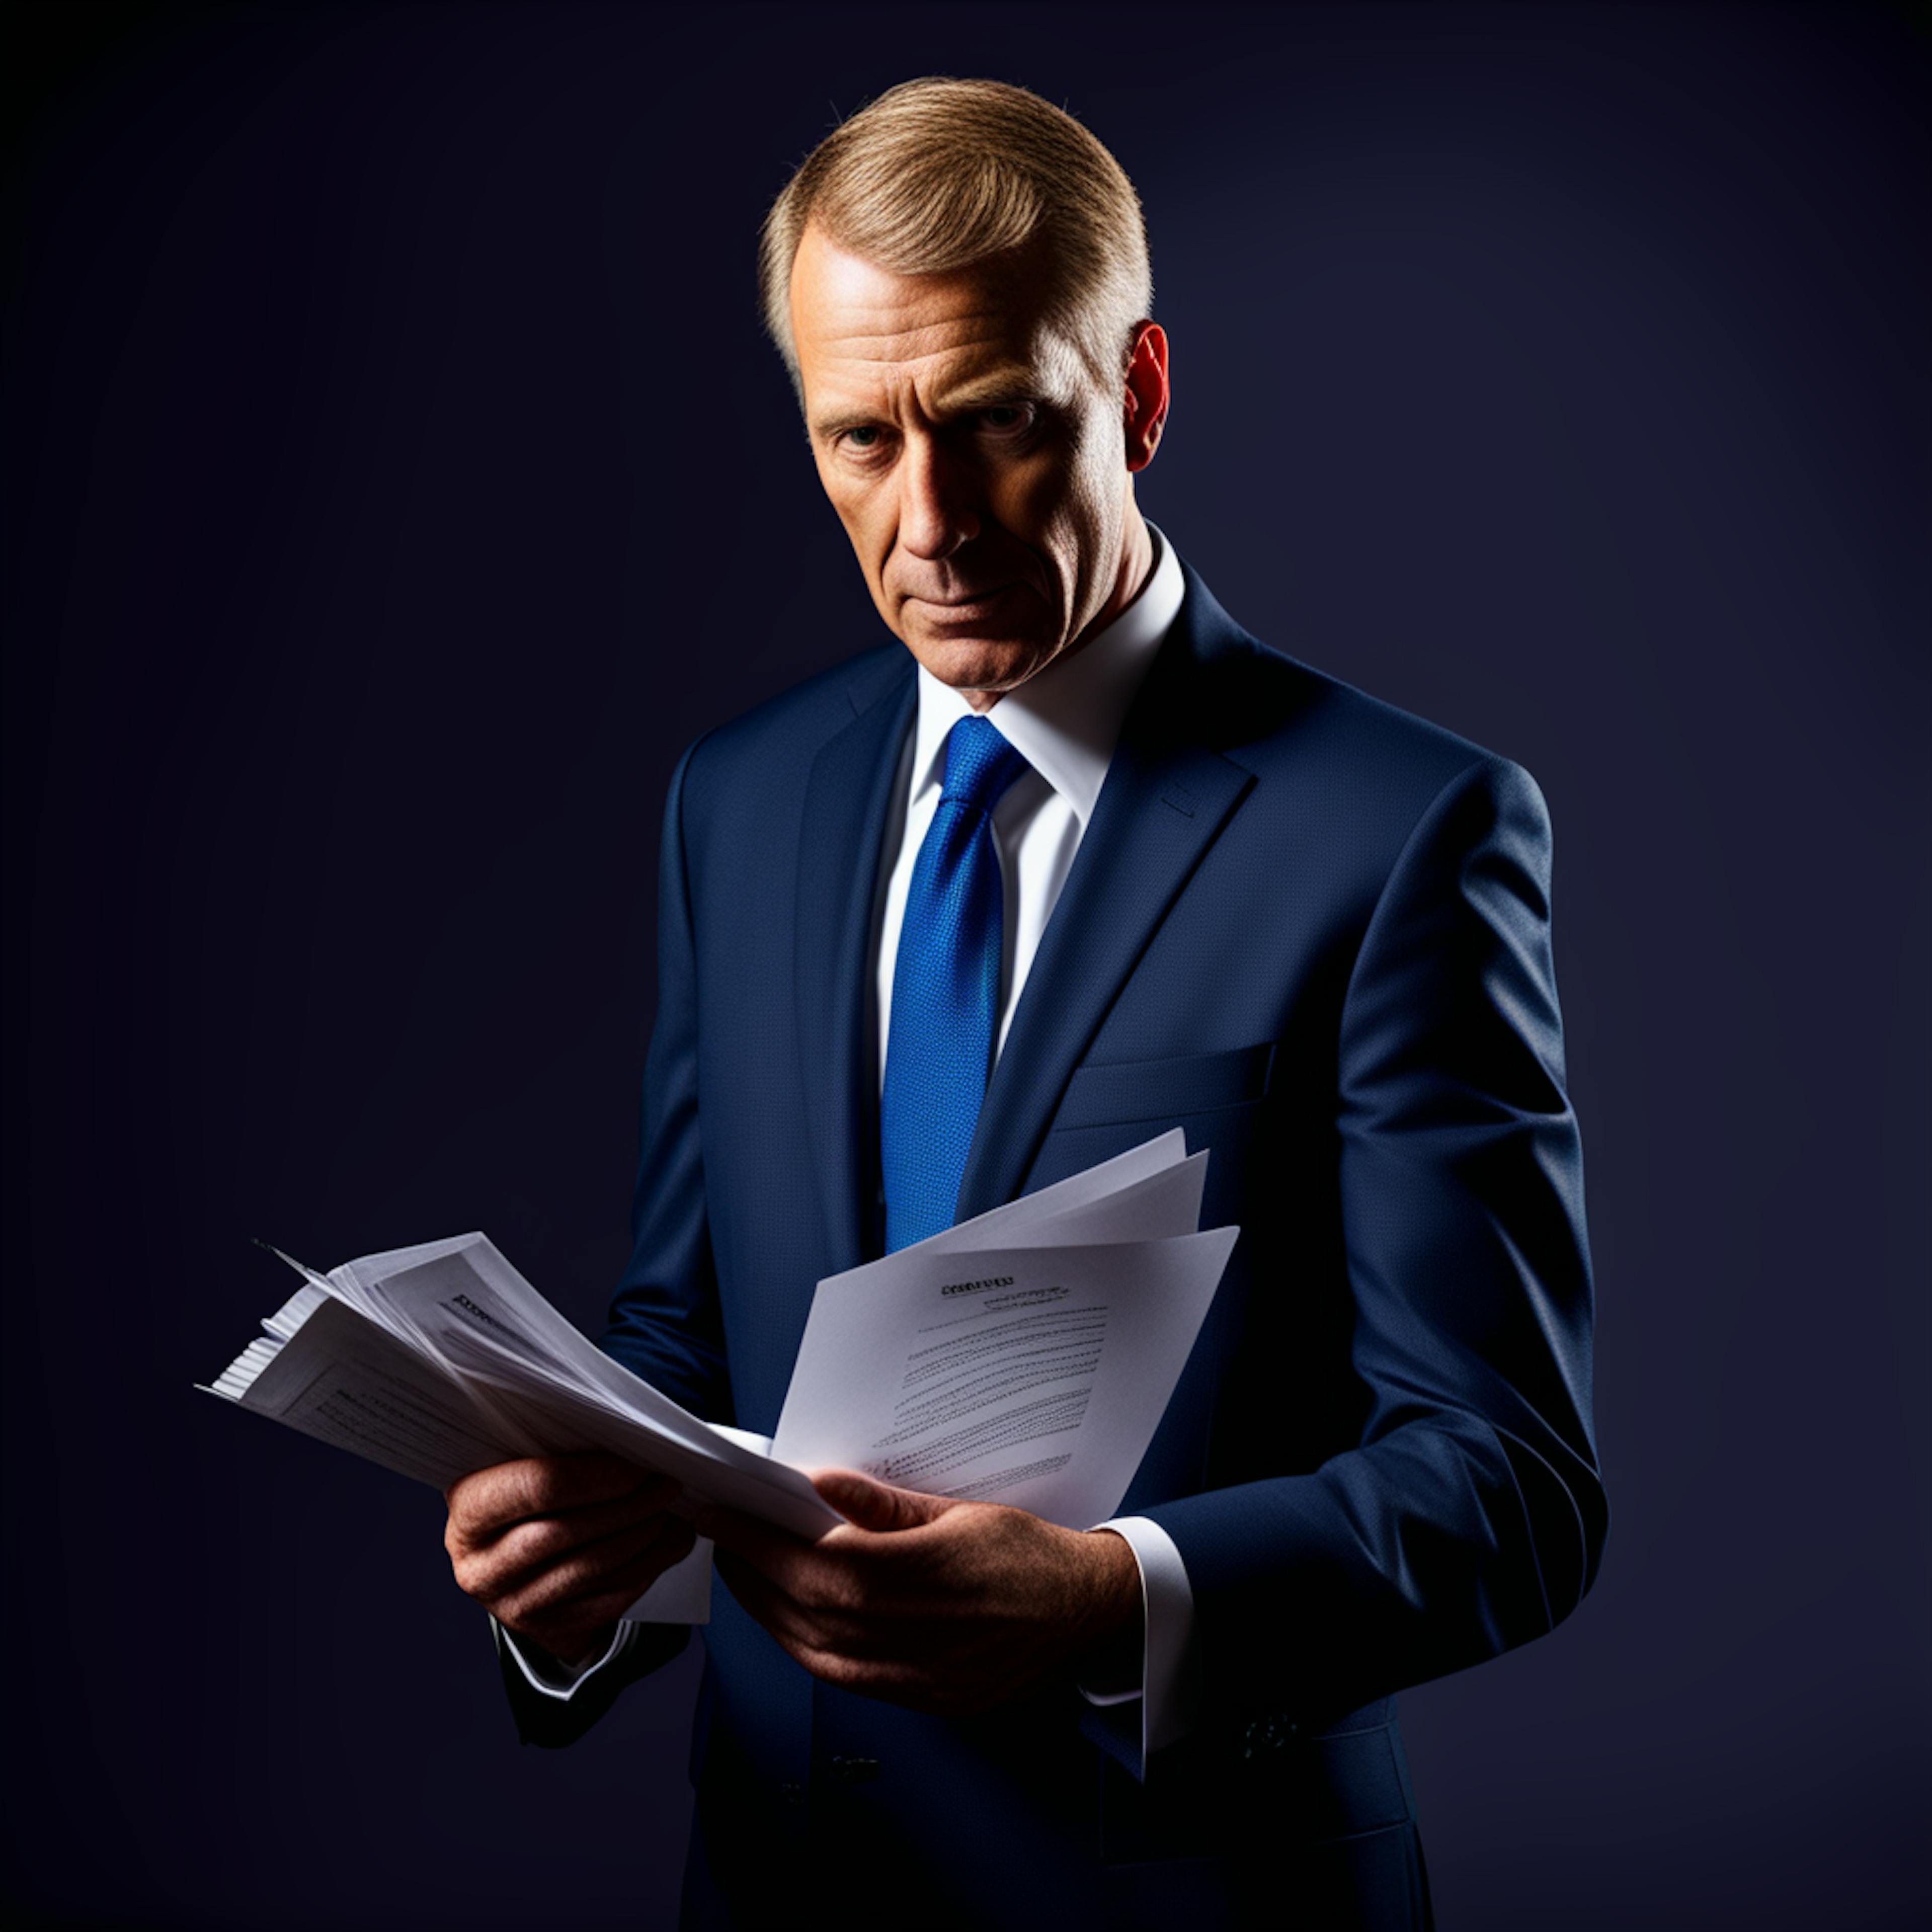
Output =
[{"x1": 442, "y1": 1451, "x2": 694, "y2": 1663}]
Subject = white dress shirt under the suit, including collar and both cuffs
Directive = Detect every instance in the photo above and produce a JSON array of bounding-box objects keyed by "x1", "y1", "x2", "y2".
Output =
[{"x1": 504, "y1": 524, "x2": 1194, "y2": 1769}]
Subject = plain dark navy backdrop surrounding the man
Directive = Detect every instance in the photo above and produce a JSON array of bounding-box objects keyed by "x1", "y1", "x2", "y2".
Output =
[{"x1": 0, "y1": 6, "x2": 1932, "y2": 1932}]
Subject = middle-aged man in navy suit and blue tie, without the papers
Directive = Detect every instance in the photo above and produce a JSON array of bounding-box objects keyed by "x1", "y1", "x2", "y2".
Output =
[{"x1": 448, "y1": 81, "x2": 1605, "y2": 1928}]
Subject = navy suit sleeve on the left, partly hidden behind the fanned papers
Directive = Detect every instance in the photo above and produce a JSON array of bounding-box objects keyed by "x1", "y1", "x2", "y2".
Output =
[{"x1": 497, "y1": 746, "x2": 731, "y2": 1748}]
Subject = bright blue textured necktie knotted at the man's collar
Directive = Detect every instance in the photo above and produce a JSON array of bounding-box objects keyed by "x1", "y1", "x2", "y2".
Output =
[{"x1": 879, "y1": 718, "x2": 1028, "y2": 1254}]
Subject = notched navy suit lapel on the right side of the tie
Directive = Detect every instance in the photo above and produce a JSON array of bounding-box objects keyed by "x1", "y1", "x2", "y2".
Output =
[{"x1": 956, "y1": 572, "x2": 1254, "y2": 1221}]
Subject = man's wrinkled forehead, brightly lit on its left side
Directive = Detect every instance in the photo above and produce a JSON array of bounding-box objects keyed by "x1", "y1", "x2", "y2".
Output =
[{"x1": 790, "y1": 228, "x2": 1078, "y2": 417}]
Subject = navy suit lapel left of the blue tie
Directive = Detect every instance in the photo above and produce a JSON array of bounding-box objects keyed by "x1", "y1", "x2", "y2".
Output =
[{"x1": 792, "y1": 653, "x2": 916, "y2": 1273}]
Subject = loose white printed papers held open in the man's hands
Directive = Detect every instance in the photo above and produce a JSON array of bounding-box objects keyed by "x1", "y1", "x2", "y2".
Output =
[{"x1": 209, "y1": 1129, "x2": 1238, "y2": 1623}]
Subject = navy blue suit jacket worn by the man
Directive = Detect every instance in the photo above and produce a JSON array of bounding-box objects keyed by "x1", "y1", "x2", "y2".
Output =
[{"x1": 502, "y1": 572, "x2": 1605, "y2": 1924}]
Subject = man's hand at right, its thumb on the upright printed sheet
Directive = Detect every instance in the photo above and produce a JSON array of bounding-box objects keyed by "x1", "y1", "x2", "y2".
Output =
[{"x1": 697, "y1": 1470, "x2": 1140, "y2": 1716}]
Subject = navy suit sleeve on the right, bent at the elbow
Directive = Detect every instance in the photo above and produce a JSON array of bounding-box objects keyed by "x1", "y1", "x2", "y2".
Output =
[{"x1": 1146, "y1": 759, "x2": 1607, "y2": 1725}]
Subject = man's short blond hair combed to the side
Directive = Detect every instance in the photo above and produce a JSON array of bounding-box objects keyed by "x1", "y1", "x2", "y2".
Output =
[{"x1": 759, "y1": 75, "x2": 1153, "y2": 386}]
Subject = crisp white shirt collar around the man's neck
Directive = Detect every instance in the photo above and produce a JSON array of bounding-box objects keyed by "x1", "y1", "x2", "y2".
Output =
[{"x1": 908, "y1": 524, "x2": 1186, "y2": 827}]
